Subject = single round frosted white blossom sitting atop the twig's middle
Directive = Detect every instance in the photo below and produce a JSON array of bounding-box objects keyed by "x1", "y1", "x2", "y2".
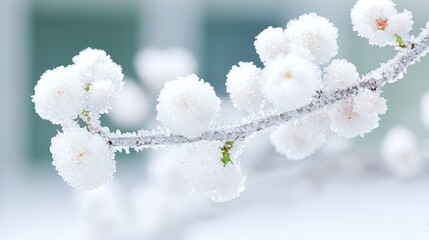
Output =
[{"x1": 156, "y1": 75, "x2": 220, "y2": 138}]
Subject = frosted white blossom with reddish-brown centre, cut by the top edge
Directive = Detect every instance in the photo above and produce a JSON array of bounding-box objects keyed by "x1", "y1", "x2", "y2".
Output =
[{"x1": 351, "y1": 0, "x2": 414, "y2": 47}]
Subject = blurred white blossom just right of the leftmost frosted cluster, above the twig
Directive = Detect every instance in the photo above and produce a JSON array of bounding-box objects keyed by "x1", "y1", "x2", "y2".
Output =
[{"x1": 108, "y1": 80, "x2": 150, "y2": 128}]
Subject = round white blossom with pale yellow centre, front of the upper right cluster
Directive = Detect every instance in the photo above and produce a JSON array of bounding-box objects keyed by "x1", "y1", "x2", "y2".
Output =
[{"x1": 261, "y1": 54, "x2": 321, "y2": 110}]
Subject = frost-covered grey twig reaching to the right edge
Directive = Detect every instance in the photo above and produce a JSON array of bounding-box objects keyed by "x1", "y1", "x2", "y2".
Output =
[{"x1": 108, "y1": 24, "x2": 429, "y2": 149}]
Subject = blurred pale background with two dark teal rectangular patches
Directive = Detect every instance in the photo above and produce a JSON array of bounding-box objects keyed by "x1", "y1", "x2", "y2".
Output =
[{"x1": 0, "y1": 0, "x2": 429, "y2": 240}]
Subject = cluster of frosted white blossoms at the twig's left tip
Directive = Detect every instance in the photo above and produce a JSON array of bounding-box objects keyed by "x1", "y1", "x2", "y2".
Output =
[{"x1": 32, "y1": 48, "x2": 124, "y2": 189}]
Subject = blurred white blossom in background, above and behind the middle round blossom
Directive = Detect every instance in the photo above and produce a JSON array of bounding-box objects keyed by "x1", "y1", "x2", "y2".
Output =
[{"x1": 134, "y1": 47, "x2": 198, "y2": 92}]
